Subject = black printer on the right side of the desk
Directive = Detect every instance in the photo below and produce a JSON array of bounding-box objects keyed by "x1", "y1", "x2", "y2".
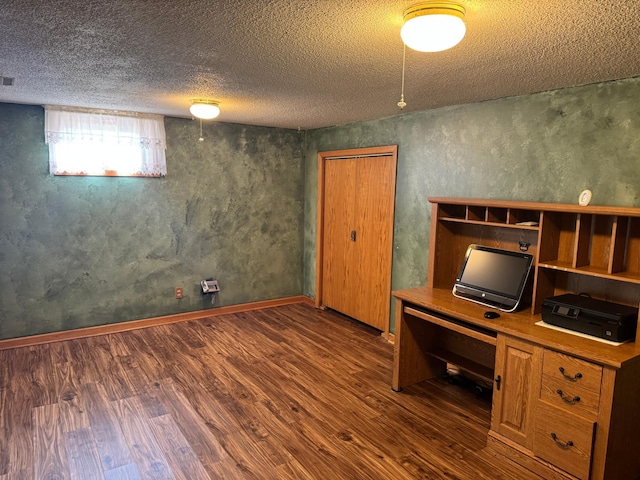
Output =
[{"x1": 542, "y1": 293, "x2": 638, "y2": 342}]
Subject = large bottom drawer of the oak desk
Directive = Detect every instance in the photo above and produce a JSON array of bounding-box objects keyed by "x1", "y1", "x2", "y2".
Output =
[{"x1": 533, "y1": 400, "x2": 595, "y2": 479}]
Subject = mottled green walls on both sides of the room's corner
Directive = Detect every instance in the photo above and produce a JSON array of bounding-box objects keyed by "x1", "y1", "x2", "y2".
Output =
[{"x1": 0, "y1": 78, "x2": 640, "y2": 338}]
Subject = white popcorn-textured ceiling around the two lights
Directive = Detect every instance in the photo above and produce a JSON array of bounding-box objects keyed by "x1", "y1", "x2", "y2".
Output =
[{"x1": 0, "y1": 0, "x2": 640, "y2": 129}]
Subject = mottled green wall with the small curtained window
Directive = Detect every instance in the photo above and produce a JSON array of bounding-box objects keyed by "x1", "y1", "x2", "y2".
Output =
[{"x1": 0, "y1": 103, "x2": 304, "y2": 339}]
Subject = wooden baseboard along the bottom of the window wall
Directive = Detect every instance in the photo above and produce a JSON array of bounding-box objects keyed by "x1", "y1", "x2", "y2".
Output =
[{"x1": 0, "y1": 295, "x2": 315, "y2": 350}]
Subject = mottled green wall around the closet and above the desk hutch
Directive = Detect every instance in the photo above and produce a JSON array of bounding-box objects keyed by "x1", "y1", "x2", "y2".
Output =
[{"x1": 304, "y1": 78, "x2": 640, "y2": 330}]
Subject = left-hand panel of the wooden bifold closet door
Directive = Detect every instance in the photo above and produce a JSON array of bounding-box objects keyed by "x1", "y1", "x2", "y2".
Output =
[{"x1": 322, "y1": 159, "x2": 358, "y2": 318}]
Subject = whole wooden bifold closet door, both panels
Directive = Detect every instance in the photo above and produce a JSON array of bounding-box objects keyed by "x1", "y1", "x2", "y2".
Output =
[{"x1": 322, "y1": 156, "x2": 396, "y2": 331}]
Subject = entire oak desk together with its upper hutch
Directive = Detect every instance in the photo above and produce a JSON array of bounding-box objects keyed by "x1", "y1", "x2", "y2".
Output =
[{"x1": 392, "y1": 198, "x2": 640, "y2": 480}]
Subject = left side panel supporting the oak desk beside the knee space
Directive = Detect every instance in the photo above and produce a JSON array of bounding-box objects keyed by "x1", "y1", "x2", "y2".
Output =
[{"x1": 391, "y1": 299, "x2": 446, "y2": 392}]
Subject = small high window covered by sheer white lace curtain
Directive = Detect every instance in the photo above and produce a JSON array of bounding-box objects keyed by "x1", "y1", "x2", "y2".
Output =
[{"x1": 44, "y1": 107, "x2": 167, "y2": 177}]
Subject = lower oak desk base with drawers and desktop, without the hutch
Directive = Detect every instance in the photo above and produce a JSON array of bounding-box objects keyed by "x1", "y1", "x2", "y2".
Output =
[{"x1": 392, "y1": 287, "x2": 640, "y2": 480}]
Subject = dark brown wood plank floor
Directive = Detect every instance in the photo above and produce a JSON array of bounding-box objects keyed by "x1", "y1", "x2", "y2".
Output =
[{"x1": 0, "y1": 304, "x2": 539, "y2": 480}]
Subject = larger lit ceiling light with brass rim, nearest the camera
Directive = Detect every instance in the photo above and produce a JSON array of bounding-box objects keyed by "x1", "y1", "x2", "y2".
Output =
[{"x1": 400, "y1": 2, "x2": 467, "y2": 52}]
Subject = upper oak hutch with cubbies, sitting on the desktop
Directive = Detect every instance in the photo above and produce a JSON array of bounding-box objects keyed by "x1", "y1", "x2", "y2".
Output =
[{"x1": 428, "y1": 198, "x2": 640, "y2": 314}]
